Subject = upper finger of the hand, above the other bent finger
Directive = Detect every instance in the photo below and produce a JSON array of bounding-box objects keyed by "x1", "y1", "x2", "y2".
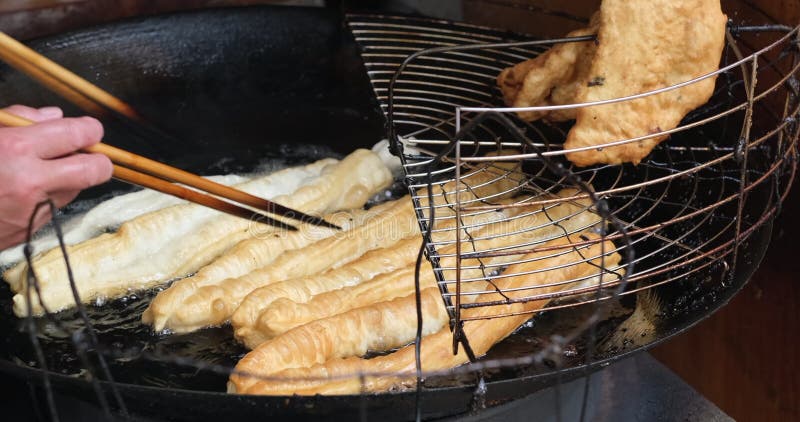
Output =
[{"x1": 3, "y1": 117, "x2": 103, "y2": 159}]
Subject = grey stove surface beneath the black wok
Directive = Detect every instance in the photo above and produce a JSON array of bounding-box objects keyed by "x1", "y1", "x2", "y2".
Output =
[{"x1": 0, "y1": 353, "x2": 733, "y2": 422}]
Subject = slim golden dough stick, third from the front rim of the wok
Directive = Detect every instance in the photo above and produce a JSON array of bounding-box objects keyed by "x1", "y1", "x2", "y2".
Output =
[{"x1": 241, "y1": 189, "x2": 599, "y2": 345}]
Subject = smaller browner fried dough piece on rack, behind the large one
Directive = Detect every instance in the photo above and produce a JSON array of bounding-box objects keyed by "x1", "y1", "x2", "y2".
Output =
[{"x1": 497, "y1": 13, "x2": 599, "y2": 121}]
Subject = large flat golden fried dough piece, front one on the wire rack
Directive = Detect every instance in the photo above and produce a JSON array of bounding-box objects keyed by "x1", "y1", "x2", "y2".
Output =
[{"x1": 564, "y1": 0, "x2": 727, "y2": 166}]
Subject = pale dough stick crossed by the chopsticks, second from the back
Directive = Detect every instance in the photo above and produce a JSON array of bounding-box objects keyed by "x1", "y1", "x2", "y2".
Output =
[{"x1": 7, "y1": 150, "x2": 392, "y2": 315}]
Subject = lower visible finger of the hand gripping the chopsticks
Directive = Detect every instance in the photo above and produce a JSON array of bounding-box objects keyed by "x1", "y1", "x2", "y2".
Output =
[{"x1": 40, "y1": 154, "x2": 113, "y2": 193}]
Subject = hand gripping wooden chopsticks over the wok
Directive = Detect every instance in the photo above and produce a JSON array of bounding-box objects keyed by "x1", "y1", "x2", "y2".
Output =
[{"x1": 0, "y1": 105, "x2": 112, "y2": 250}]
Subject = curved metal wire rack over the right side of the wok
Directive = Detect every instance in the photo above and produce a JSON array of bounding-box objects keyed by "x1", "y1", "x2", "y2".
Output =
[{"x1": 349, "y1": 15, "x2": 798, "y2": 352}]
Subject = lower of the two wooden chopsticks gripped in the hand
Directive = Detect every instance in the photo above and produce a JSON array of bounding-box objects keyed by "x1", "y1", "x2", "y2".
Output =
[{"x1": 0, "y1": 110, "x2": 297, "y2": 230}]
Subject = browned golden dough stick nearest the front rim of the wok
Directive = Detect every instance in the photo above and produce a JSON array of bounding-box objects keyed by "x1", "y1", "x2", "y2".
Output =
[{"x1": 228, "y1": 232, "x2": 620, "y2": 395}]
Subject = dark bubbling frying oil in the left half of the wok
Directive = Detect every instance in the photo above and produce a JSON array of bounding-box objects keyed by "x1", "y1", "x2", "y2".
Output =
[{"x1": 0, "y1": 144, "x2": 407, "y2": 391}]
